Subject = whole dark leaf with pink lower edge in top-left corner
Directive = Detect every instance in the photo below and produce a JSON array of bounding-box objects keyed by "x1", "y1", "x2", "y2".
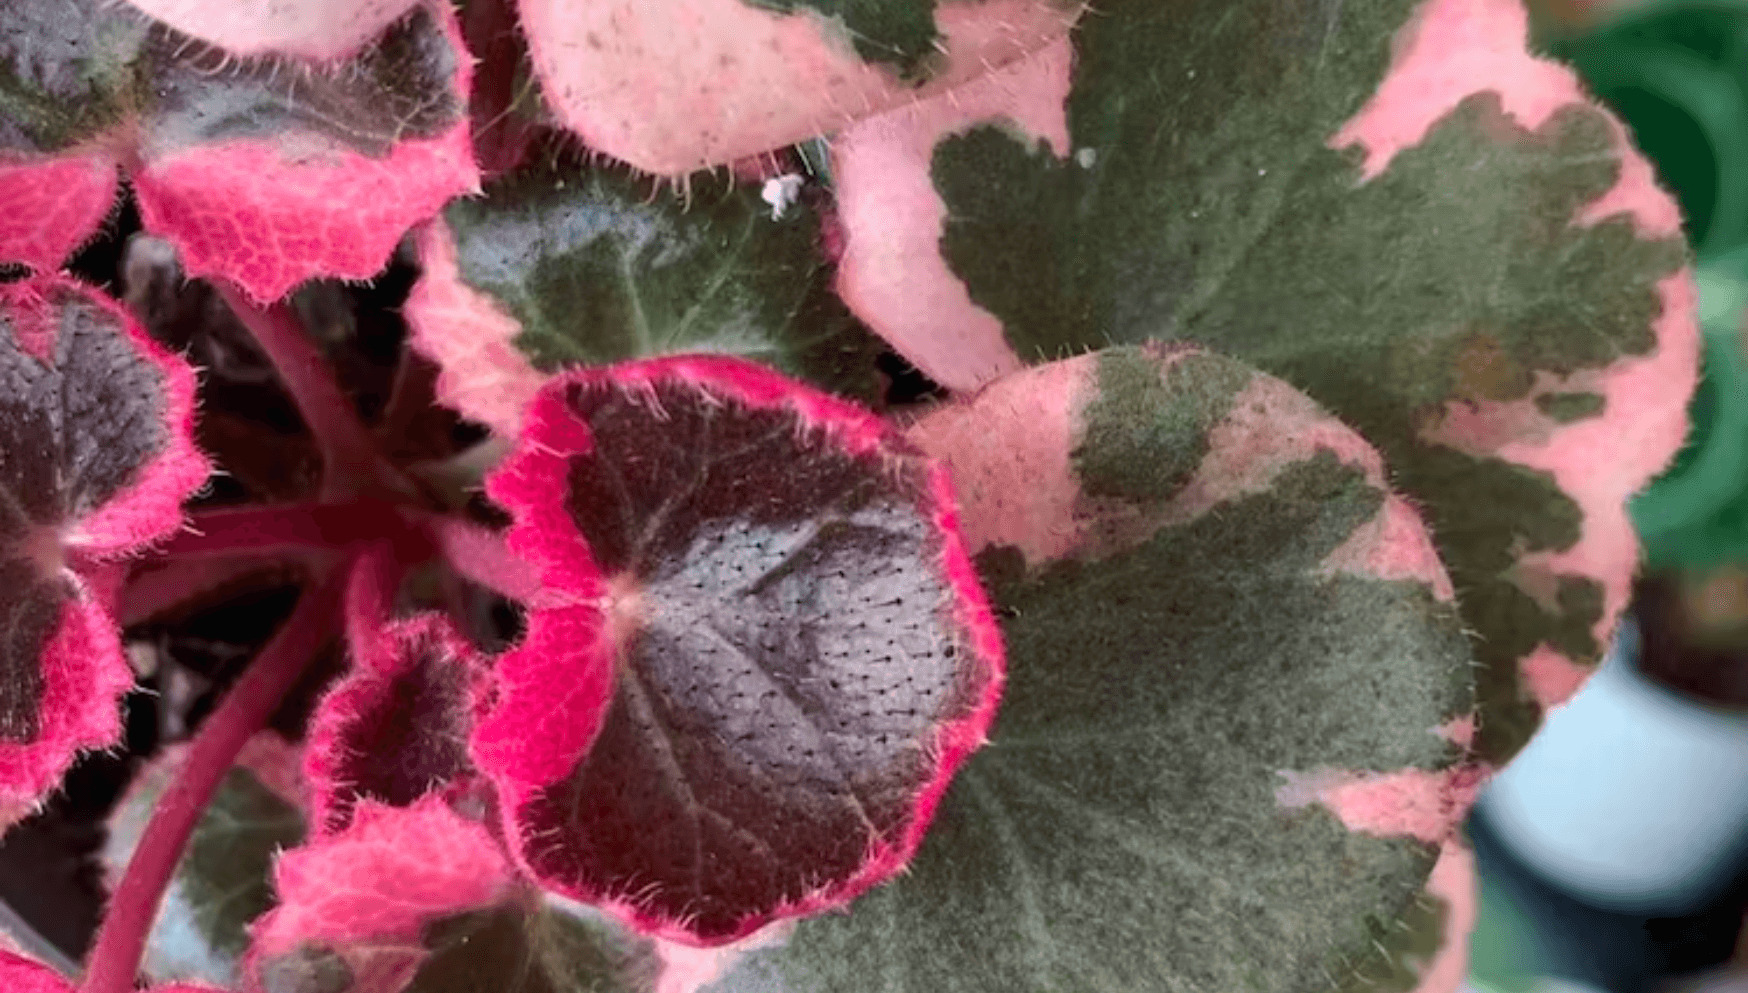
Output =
[{"x1": 0, "y1": 0, "x2": 479, "y2": 301}]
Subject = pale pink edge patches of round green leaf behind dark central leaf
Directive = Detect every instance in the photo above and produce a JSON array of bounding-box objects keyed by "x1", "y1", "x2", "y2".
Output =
[{"x1": 915, "y1": 343, "x2": 1491, "y2": 993}]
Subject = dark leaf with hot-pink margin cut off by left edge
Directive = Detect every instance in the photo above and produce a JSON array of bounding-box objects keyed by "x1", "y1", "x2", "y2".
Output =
[{"x1": 0, "y1": 276, "x2": 208, "y2": 822}]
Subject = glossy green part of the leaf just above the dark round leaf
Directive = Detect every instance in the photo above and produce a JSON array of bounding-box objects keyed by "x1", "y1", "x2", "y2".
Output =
[{"x1": 423, "y1": 157, "x2": 877, "y2": 399}]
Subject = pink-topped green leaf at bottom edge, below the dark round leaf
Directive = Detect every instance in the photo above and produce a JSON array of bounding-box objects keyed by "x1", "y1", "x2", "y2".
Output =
[{"x1": 248, "y1": 797, "x2": 662, "y2": 993}]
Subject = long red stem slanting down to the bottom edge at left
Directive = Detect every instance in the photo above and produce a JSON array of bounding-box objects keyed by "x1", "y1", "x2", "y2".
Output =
[{"x1": 80, "y1": 570, "x2": 348, "y2": 993}]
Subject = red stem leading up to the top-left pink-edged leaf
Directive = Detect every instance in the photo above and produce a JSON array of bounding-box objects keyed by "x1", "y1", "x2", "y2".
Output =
[{"x1": 213, "y1": 280, "x2": 400, "y2": 500}]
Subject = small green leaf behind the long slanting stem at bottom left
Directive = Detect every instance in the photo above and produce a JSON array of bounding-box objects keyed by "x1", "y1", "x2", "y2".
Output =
[{"x1": 100, "y1": 733, "x2": 304, "y2": 988}]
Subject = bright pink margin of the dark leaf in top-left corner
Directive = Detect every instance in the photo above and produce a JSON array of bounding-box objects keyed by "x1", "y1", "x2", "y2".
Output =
[{"x1": 0, "y1": 0, "x2": 481, "y2": 304}]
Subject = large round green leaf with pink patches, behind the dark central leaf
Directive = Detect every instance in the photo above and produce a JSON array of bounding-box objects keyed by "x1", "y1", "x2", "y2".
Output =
[{"x1": 710, "y1": 348, "x2": 1472, "y2": 993}]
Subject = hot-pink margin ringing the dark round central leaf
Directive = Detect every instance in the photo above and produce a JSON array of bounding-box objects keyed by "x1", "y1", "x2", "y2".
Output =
[{"x1": 474, "y1": 355, "x2": 1007, "y2": 948}]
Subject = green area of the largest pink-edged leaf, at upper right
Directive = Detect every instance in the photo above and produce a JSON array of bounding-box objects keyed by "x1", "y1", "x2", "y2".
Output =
[{"x1": 933, "y1": 0, "x2": 1687, "y2": 760}]
